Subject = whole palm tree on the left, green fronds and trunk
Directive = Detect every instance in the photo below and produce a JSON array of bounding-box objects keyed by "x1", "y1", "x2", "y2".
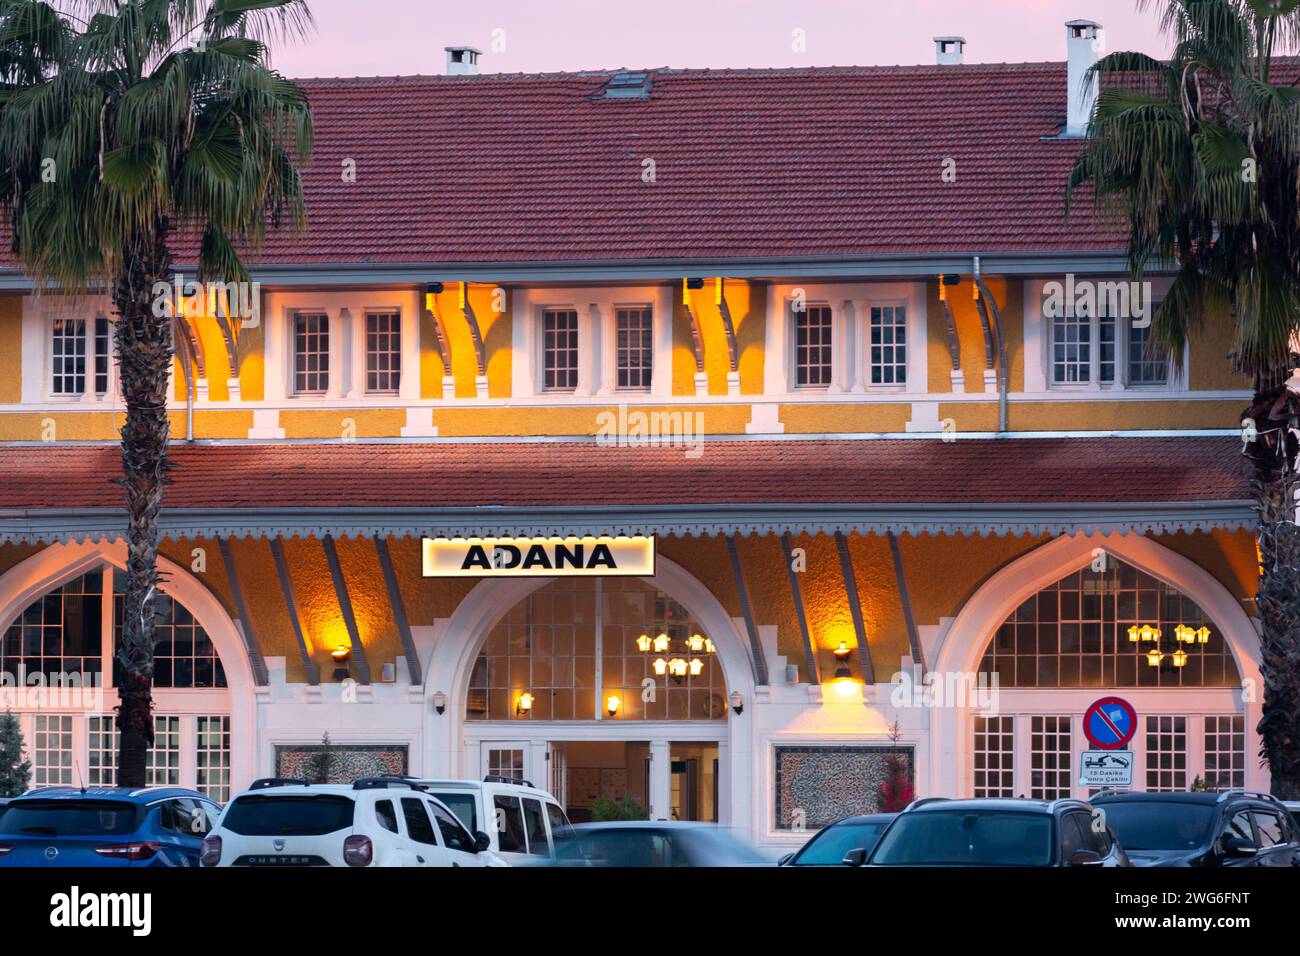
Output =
[{"x1": 0, "y1": 0, "x2": 312, "y2": 787}]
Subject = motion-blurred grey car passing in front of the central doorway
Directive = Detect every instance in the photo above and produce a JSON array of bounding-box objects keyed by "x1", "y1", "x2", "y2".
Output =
[{"x1": 555, "y1": 821, "x2": 772, "y2": 866}]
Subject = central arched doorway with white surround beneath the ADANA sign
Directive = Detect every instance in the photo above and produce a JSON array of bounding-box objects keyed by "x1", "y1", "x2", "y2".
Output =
[{"x1": 426, "y1": 557, "x2": 753, "y2": 822}]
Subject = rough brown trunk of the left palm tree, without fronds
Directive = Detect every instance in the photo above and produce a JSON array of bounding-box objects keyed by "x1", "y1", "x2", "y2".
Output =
[{"x1": 113, "y1": 221, "x2": 172, "y2": 787}]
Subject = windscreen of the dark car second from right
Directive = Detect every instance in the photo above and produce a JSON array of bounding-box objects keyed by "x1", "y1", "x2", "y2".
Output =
[{"x1": 871, "y1": 810, "x2": 1052, "y2": 866}]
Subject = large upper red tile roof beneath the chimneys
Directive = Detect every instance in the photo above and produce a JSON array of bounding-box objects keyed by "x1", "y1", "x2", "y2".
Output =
[{"x1": 257, "y1": 64, "x2": 1122, "y2": 263}]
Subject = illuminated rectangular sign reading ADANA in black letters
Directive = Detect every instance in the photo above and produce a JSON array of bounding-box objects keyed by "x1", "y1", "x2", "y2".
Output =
[{"x1": 423, "y1": 536, "x2": 654, "y2": 578}]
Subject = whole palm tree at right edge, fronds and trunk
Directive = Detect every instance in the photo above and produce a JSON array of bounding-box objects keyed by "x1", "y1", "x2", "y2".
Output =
[{"x1": 1066, "y1": 0, "x2": 1300, "y2": 799}]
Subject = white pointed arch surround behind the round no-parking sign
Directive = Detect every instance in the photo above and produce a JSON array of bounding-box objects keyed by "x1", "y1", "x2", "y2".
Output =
[{"x1": 931, "y1": 533, "x2": 1269, "y2": 795}]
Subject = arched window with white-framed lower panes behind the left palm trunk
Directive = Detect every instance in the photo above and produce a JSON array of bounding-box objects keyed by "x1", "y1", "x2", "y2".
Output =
[{"x1": 0, "y1": 564, "x2": 230, "y2": 801}]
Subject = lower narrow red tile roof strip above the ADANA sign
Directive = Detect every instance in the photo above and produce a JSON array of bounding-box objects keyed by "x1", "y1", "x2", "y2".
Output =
[{"x1": 0, "y1": 437, "x2": 1249, "y2": 512}]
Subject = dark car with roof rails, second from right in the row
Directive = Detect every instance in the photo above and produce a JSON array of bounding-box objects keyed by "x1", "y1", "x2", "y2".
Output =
[{"x1": 845, "y1": 799, "x2": 1132, "y2": 866}]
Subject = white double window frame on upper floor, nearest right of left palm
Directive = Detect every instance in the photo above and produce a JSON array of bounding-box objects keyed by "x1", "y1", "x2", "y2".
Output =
[{"x1": 264, "y1": 289, "x2": 424, "y2": 407}]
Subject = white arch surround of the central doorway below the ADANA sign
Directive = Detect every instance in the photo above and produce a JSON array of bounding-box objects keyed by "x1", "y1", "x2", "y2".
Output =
[{"x1": 424, "y1": 555, "x2": 755, "y2": 826}]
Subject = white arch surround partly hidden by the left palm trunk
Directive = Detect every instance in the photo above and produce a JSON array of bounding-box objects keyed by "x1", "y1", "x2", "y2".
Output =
[{"x1": 0, "y1": 540, "x2": 257, "y2": 793}]
